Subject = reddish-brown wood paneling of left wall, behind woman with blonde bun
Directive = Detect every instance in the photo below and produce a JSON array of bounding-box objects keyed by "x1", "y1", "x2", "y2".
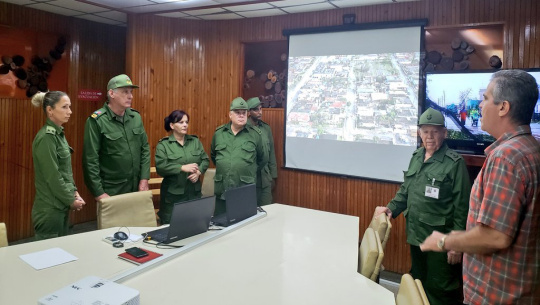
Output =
[{"x1": 0, "y1": 2, "x2": 125, "y2": 241}]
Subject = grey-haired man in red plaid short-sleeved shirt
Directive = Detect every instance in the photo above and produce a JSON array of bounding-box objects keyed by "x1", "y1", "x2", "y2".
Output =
[{"x1": 420, "y1": 70, "x2": 540, "y2": 305}]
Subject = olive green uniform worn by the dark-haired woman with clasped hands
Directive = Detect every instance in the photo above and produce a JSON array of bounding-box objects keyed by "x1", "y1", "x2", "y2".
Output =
[{"x1": 156, "y1": 134, "x2": 210, "y2": 224}]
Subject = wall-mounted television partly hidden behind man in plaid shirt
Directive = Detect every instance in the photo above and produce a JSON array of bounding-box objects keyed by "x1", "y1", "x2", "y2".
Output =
[{"x1": 424, "y1": 69, "x2": 540, "y2": 154}]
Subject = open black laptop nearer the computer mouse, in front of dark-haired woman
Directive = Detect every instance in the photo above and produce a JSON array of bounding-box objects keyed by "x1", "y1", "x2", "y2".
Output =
[{"x1": 146, "y1": 196, "x2": 216, "y2": 244}]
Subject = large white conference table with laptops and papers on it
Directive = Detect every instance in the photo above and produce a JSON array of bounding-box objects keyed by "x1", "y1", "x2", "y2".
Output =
[{"x1": 0, "y1": 204, "x2": 395, "y2": 305}]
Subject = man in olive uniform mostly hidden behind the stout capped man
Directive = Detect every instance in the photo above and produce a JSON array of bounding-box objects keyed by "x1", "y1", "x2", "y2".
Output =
[{"x1": 247, "y1": 97, "x2": 277, "y2": 205}]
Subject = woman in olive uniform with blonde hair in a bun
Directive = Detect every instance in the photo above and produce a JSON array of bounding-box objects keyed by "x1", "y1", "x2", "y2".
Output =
[{"x1": 32, "y1": 91, "x2": 85, "y2": 240}]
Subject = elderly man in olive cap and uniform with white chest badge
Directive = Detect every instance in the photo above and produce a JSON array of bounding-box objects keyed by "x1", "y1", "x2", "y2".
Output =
[{"x1": 375, "y1": 108, "x2": 471, "y2": 304}]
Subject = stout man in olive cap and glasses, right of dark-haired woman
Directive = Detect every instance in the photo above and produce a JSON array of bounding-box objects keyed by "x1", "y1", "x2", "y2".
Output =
[{"x1": 210, "y1": 97, "x2": 268, "y2": 215}]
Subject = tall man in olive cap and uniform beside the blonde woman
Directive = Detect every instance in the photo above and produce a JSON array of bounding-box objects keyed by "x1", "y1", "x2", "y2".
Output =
[{"x1": 83, "y1": 74, "x2": 150, "y2": 201}]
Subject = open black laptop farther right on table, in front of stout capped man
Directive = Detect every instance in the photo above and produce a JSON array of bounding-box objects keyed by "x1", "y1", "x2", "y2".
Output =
[{"x1": 212, "y1": 184, "x2": 257, "y2": 227}]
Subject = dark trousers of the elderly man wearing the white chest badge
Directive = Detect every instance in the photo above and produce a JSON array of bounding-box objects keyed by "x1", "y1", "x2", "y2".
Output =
[{"x1": 411, "y1": 245, "x2": 463, "y2": 305}]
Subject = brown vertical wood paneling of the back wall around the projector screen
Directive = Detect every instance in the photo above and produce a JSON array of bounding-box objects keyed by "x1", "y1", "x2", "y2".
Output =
[{"x1": 128, "y1": 0, "x2": 540, "y2": 272}]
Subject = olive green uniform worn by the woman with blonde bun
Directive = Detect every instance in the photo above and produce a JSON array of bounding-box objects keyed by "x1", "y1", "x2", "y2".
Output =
[{"x1": 32, "y1": 119, "x2": 77, "y2": 240}]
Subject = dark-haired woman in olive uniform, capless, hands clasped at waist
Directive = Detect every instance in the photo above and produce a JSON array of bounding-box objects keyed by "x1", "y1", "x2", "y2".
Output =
[{"x1": 156, "y1": 110, "x2": 209, "y2": 224}]
